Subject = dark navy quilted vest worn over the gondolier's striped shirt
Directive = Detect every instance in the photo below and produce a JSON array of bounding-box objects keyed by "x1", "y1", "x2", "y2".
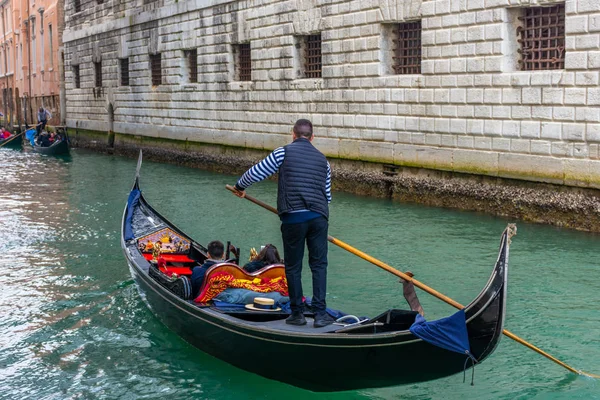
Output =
[{"x1": 277, "y1": 138, "x2": 329, "y2": 219}]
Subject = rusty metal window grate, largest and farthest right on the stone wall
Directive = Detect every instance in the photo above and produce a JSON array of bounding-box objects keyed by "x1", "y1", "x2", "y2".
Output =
[{"x1": 517, "y1": 4, "x2": 565, "y2": 71}]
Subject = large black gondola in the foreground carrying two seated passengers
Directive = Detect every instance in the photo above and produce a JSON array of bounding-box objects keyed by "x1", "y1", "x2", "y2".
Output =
[{"x1": 121, "y1": 153, "x2": 510, "y2": 391}]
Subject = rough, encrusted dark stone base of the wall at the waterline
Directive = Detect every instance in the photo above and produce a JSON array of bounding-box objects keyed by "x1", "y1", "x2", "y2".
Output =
[{"x1": 71, "y1": 130, "x2": 600, "y2": 232}]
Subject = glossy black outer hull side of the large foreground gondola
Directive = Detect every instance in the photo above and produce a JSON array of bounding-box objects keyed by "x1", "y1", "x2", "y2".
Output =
[{"x1": 126, "y1": 256, "x2": 488, "y2": 391}]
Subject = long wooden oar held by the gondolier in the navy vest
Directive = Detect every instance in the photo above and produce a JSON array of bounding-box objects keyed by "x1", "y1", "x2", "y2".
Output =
[{"x1": 225, "y1": 185, "x2": 600, "y2": 378}]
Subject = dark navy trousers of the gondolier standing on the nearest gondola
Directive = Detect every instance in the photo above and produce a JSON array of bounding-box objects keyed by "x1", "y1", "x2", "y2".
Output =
[{"x1": 281, "y1": 217, "x2": 329, "y2": 313}]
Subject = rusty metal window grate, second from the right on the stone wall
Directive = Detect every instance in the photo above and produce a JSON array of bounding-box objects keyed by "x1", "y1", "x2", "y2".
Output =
[{"x1": 393, "y1": 21, "x2": 421, "y2": 75}]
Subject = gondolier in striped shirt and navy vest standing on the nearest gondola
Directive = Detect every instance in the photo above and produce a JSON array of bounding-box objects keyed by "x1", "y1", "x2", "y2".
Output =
[{"x1": 235, "y1": 119, "x2": 333, "y2": 328}]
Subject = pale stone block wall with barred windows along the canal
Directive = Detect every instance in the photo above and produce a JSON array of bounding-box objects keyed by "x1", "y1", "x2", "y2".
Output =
[{"x1": 64, "y1": 0, "x2": 600, "y2": 188}]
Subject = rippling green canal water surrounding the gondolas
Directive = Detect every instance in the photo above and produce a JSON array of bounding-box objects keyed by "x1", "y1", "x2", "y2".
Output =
[{"x1": 0, "y1": 149, "x2": 600, "y2": 399}]
